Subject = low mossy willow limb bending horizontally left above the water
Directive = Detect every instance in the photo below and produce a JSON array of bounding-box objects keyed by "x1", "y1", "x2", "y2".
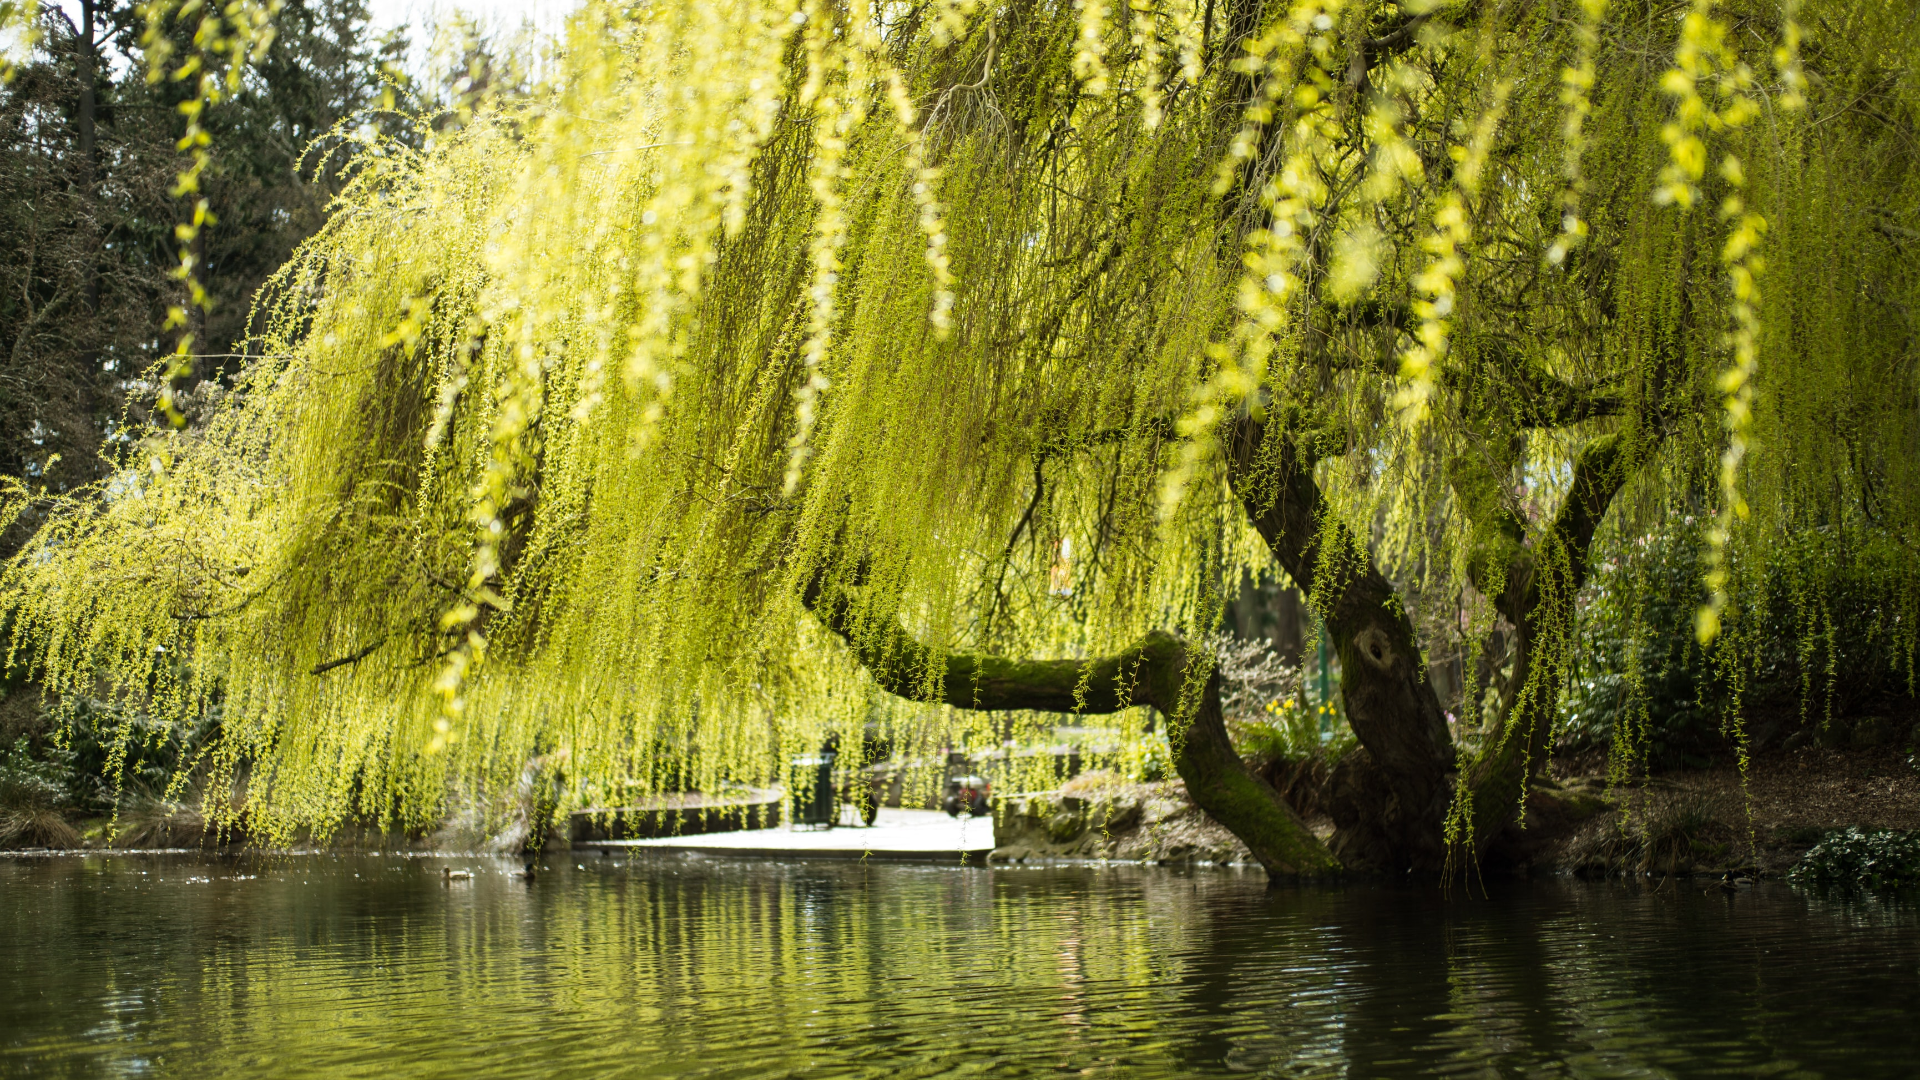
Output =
[{"x1": 801, "y1": 575, "x2": 1340, "y2": 876}]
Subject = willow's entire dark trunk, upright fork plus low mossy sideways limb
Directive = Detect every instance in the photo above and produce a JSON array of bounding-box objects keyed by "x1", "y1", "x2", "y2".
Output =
[{"x1": 803, "y1": 415, "x2": 1634, "y2": 876}]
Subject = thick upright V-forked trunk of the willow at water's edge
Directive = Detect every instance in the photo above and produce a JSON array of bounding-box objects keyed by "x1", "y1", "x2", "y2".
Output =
[{"x1": 1223, "y1": 411, "x2": 1651, "y2": 871}]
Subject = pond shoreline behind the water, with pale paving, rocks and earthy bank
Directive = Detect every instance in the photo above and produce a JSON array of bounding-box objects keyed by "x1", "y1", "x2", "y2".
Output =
[{"x1": 0, "y1": 746, "x2": 1920, "y2": 878}]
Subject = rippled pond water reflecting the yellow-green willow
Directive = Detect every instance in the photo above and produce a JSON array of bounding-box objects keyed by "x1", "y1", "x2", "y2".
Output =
[{"x1": 0, "y1": 855, "x2": 1920, "y2": 1080}]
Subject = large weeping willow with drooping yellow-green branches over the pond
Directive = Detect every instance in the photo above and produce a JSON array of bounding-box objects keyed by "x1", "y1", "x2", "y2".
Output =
[{"x1": 0, "y1": 0, "x2": 1920, "y2": 874}]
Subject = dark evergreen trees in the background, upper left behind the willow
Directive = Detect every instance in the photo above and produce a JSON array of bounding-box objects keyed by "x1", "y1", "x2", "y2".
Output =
[{"x1": 0, "y1": 0, "x2": 405, "y2": 503}]
